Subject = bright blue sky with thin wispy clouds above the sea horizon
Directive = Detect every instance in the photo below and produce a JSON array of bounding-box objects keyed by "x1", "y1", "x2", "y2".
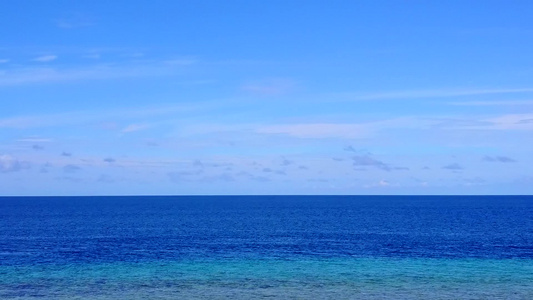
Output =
[{"x1": 0, "y1": 0, "x2": 533, "y2": 196}]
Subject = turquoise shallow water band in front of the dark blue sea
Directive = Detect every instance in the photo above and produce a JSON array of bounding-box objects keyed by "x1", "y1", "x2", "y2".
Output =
[{"x1": 0, "y1": 258, "x2": 533, "y2": 299}]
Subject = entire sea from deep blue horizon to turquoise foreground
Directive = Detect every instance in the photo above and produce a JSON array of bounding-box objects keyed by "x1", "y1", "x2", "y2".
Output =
[{"x1": 0, "y1": 196, "x2": 533, "y2": 300}]
